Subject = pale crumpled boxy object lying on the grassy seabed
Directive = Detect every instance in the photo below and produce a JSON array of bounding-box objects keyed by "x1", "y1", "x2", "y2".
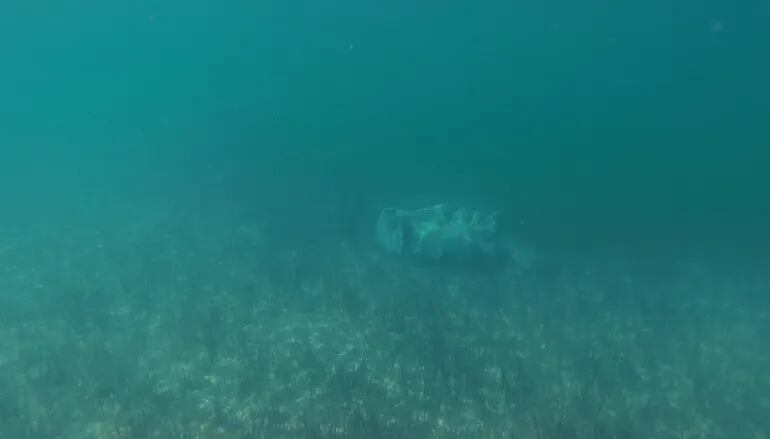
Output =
[{"x1": 377, "y1": 204, "x2": 499, "y2": 263}]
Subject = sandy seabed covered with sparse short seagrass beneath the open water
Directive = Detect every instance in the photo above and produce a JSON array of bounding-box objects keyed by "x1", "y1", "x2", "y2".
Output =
[{"x1": 0, "y1": 206, "x2": 770, "y2": 439}]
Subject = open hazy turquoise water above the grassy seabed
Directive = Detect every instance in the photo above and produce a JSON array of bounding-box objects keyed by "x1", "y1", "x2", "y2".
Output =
[{"x1": 2, "y1": 1, "x2": 770, "y2": 237}]
